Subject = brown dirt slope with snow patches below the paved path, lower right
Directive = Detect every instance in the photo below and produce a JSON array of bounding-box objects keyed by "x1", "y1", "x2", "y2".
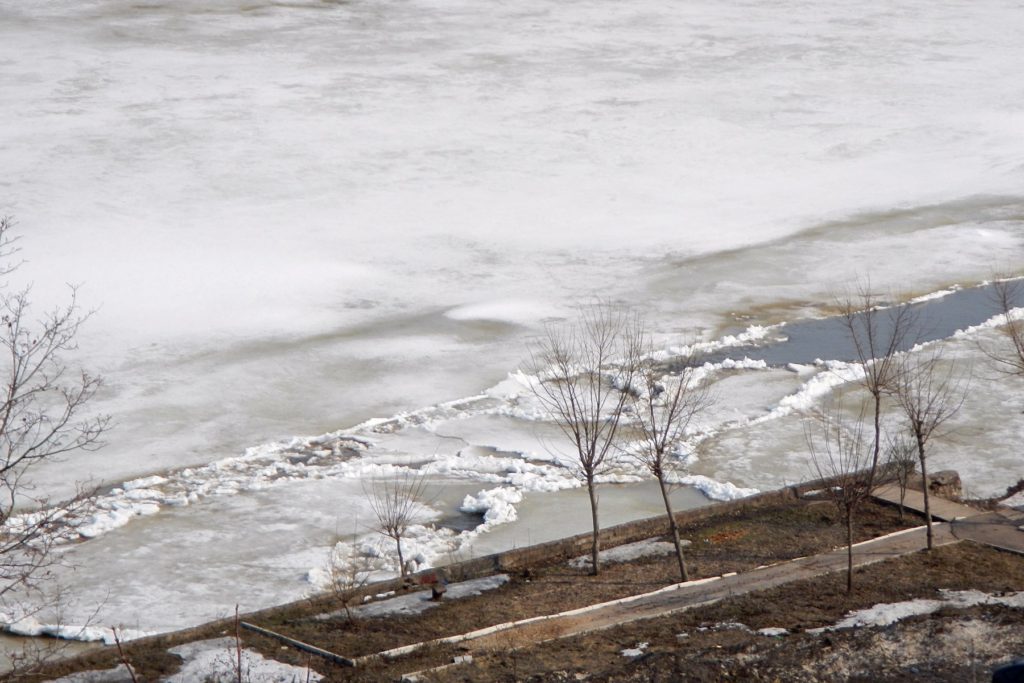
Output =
[{"x1": 446, "y1": 543, "x2": 1024, "y2": 682}]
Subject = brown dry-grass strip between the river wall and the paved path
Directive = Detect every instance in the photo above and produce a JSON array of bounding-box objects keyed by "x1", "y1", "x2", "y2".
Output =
[{"x1": 32, "y1": 501, "x2": 919, "y2": 681}]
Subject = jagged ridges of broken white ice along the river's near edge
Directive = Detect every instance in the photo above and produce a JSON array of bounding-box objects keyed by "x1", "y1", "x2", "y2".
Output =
[{"x1": 5, "y1": 284, "x2": 1024, "y2": 640}]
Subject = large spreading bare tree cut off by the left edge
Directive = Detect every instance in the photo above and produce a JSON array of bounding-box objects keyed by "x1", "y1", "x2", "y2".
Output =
[{"x1": 0, "y1": 218, "x2": 110, "y2": 626}]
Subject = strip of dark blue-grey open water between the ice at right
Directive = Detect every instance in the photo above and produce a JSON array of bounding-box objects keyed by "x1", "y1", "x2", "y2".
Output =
[{"x1": 701, "y1": 284, "x2": 1024, "y2": 367}]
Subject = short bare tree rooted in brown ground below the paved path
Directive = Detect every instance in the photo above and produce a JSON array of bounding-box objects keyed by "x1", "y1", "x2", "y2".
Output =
[{"x1": 804, "y1": 404, "x2": 873, "y2": 593}]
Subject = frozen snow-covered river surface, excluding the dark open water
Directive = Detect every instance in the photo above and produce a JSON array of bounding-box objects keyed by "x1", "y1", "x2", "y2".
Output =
[{"x1": 0, "y1": 0, "x2": 1024, "y2": 647}]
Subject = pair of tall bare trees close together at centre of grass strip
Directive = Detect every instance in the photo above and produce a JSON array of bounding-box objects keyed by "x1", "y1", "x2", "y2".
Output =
[{"x1": 530, "y1": 302, "x2": 712, "y2": 581}]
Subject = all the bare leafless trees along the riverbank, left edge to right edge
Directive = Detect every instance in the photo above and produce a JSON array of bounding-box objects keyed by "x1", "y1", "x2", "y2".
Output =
[{"x1": 0, "y1": 206, "x2": 1024, "y2": 655}]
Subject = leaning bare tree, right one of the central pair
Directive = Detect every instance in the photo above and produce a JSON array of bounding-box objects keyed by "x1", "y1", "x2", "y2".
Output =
[{"x1": 630, "y1": 345, "x2": 712, "y2": 581}]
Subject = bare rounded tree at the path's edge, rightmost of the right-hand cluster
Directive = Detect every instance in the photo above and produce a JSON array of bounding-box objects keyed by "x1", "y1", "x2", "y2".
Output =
[{"x1": 896, "y1": 346, "x2": 970, "y2": 550}]
